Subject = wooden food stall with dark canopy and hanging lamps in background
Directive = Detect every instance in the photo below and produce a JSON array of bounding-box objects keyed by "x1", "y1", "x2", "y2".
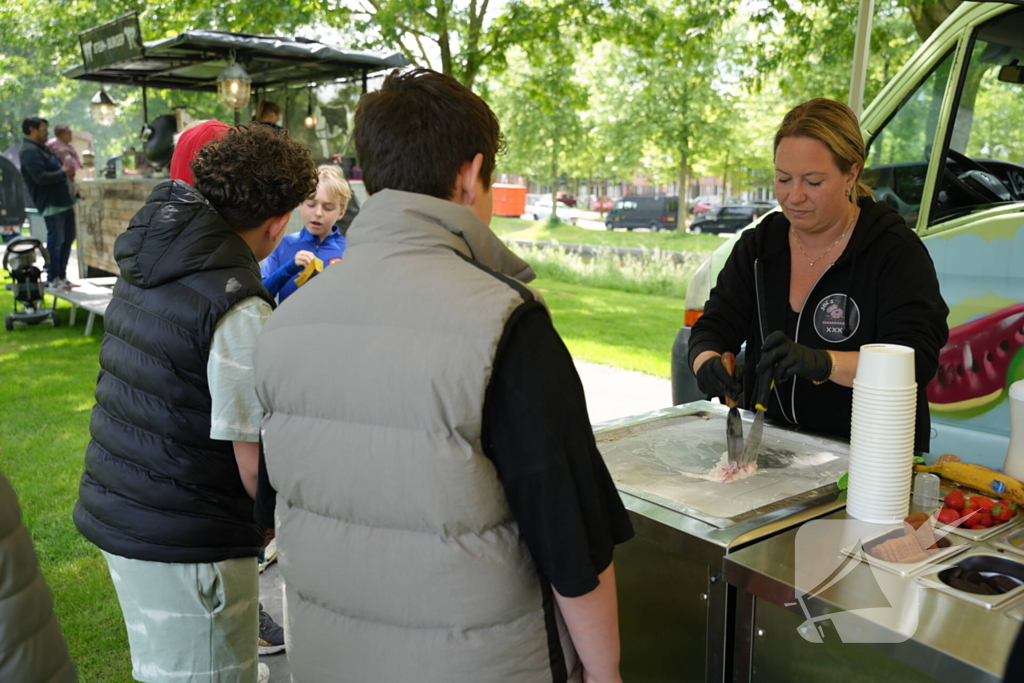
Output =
[{"x1": 65, "y1": 12, "x2": 409, "y2": 278}]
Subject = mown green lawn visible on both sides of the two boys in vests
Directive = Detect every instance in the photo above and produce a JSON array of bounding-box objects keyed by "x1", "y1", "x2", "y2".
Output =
[{"x1": 0, "y1": 270, "x2": 683, "y2": 683}]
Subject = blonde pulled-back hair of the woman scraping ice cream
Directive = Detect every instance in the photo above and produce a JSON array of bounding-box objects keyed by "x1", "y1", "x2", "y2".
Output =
[{"x1": 773, "y1": 97, "x2": 874, "y2": 204}]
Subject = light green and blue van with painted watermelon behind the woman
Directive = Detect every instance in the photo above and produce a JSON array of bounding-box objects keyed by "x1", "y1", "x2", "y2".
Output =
[{"x1": 672, "y1": 2, "x2": 1024, "y2": 469}]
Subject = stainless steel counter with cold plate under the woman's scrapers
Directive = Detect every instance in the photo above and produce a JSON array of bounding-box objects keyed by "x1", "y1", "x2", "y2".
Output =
[{"x1": 595, "y1": 401, "x2": 847, "y2": 681}]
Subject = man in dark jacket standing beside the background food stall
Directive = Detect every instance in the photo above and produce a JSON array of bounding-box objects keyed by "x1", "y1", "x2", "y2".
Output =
[{"x1": 19, "y1": 117, "x2": 75, "y2": 288}]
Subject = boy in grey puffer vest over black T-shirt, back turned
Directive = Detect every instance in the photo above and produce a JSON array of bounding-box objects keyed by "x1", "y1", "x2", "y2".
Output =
[{"x1": 256, "y1": 69, "x2": 633, "y2": 683}]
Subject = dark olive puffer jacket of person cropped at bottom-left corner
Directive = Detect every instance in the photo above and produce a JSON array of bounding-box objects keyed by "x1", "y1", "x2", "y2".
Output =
[{"x1": 0, "y1": 473, "x2": 78, "y2": 683}]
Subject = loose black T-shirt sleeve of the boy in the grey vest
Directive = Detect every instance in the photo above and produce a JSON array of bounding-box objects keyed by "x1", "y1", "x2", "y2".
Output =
[{"x1": 483, "y1": 302, "x2": 633, "y2": 597}]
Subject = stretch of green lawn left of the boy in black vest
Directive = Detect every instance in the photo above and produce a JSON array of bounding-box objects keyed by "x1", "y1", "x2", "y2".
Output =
[{"x1": 0, "y1": 291, "x2": 132, "y2": 683}]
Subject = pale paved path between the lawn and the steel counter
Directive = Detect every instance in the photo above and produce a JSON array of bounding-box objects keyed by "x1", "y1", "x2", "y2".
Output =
[{"x1": 260, "y1": 360, "x2": 672, "y2": 683}]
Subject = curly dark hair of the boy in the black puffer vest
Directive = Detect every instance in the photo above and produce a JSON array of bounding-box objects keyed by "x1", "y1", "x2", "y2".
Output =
[{"x1": 191, "y1": 125, "x2": 317, "y2": 231}]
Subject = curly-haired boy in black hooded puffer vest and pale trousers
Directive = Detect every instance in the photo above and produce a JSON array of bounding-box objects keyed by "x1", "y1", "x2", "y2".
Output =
[{"x1": 74, "y1": 126, "x2": 316, "y2": 683}]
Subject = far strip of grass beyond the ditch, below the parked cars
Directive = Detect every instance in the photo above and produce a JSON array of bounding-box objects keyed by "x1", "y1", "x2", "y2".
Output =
[{"x1": 490, "y1": 216, "x2": 725, "y2": 253}]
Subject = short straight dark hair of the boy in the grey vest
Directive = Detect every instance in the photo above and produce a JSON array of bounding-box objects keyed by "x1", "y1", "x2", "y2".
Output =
[{"x1": 355, "y1": 69, "x2": 505, "y2": 200}]
